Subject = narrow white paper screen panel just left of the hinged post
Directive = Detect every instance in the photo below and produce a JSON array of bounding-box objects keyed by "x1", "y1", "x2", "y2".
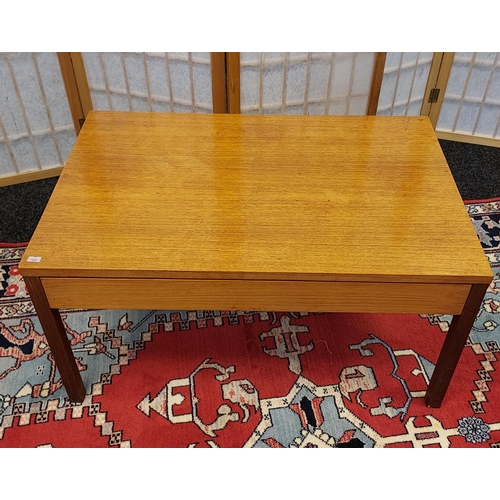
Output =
[{"x1": 377, "y1": 52, "x2": 433, "y2": 116}]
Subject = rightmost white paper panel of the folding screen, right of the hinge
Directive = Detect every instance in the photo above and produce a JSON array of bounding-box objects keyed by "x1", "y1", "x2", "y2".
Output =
[{"x1": 436, "y1": 52, "x2": 500, "y2": 139}]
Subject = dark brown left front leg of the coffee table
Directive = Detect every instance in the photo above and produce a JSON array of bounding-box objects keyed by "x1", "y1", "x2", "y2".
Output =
[{"x1": 24, "y1": 276, "x2": 85, "y2": 403}]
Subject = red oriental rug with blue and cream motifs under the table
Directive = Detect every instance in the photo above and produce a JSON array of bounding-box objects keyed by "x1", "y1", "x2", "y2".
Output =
[{"x1": 0, "y1": 196, "x2": 500, "y2": 448}]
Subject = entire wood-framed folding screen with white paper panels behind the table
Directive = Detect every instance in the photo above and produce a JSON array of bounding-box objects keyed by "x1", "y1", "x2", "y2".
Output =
[{"x1": 0, "y1": 52, "x2": 500, "y2": 186}]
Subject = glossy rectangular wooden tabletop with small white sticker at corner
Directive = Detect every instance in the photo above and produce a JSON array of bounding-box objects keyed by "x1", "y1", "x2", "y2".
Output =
[{"x1": 21, "y1": 111, "x2": 491, "y2": 283}]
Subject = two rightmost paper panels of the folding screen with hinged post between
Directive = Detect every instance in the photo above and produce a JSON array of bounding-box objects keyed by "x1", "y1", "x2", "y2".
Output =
[{"x1": 377, "y1": 52, "x2": 500, "y2": 147}]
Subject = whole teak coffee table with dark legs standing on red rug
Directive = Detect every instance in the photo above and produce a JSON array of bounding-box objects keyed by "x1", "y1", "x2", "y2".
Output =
[{"x1": 21, "y1": 111, "x2": 493, "y2": 407}]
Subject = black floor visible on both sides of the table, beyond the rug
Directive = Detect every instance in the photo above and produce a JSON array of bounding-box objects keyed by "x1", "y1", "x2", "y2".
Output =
[{"x1": 0, "y1": 141, "x2": 500, "y2": 243}]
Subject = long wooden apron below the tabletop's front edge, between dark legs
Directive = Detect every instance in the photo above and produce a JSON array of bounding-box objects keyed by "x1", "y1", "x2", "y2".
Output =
[{"x1": 41, "y1": 278, "x2": 470, "y2": 314}]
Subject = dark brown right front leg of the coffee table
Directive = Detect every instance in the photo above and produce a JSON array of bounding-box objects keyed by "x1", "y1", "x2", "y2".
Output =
[{"x1": 425, "y1": 285, "x2": 488, "y2": 408}]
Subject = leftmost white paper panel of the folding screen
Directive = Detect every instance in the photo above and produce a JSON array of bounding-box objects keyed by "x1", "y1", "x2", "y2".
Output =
[{"x1": 0, "y1": 52, "x2": 76, "y2": 177}]
